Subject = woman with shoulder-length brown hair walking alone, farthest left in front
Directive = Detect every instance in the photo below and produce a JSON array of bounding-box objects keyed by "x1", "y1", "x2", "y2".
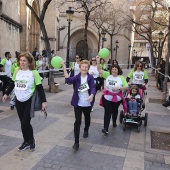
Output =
[{"x1": 2, "y1": 53, "x2": 47, "y2": 151}]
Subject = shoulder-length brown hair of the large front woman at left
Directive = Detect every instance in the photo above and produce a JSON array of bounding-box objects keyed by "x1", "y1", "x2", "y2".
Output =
[{"x1": 17, "y1": 52, "x2": 35, "y2": 70}]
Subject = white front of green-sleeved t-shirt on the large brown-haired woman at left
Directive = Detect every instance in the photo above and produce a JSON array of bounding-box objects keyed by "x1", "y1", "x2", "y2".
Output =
[{"x1": 14, "y1": 70, "x2": 34, "y2": 102}]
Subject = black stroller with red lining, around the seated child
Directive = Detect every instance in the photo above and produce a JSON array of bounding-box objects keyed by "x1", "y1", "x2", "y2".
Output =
[{"x1": 119, "y1": 84, "x2": 148, "y2": 133}]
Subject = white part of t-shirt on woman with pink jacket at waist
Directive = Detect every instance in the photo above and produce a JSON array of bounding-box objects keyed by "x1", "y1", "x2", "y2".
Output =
[{"x1": 104, "y1": 75, "x2": 123, "y2": 101}]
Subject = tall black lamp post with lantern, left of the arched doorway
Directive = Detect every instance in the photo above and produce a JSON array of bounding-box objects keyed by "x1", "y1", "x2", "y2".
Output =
[{"x1": 66, "y1": 7, "x2": 74, "y2": 68}]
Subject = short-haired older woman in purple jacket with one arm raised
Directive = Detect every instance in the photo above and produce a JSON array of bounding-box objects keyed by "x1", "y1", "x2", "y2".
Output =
[{"x1": 61, "y1": 60, "x2": 96, "y2": 150}]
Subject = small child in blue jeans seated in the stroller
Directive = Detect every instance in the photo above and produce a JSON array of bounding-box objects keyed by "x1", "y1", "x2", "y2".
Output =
[{"x1": 127, "y1": 85, "x2": 142, "y2": 116}]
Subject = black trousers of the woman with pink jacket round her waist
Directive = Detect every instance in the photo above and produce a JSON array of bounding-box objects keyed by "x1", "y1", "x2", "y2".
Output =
[{"x1": 103, "y1": 97, "x2": 121, "y2": 131}]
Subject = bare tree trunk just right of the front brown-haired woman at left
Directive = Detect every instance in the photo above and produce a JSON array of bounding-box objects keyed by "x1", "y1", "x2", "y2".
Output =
[{"x1": 40, "y1": 22, "x2": 54, "y2": 92}]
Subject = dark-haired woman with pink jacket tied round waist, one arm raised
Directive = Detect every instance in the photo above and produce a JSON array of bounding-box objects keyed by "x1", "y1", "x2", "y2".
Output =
[{"x1": 97, "y1": 57, "x2": 128, "y2": 134}]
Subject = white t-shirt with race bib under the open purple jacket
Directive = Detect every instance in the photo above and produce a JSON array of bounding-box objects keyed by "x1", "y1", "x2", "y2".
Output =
[{"x1": 78, "y1": 75, "x2": 91, "y2": 107}]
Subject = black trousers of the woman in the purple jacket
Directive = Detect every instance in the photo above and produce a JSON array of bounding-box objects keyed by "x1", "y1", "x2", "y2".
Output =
[{"x1": 74, "y1": 106, "x2": 91, "y2": 143}]
